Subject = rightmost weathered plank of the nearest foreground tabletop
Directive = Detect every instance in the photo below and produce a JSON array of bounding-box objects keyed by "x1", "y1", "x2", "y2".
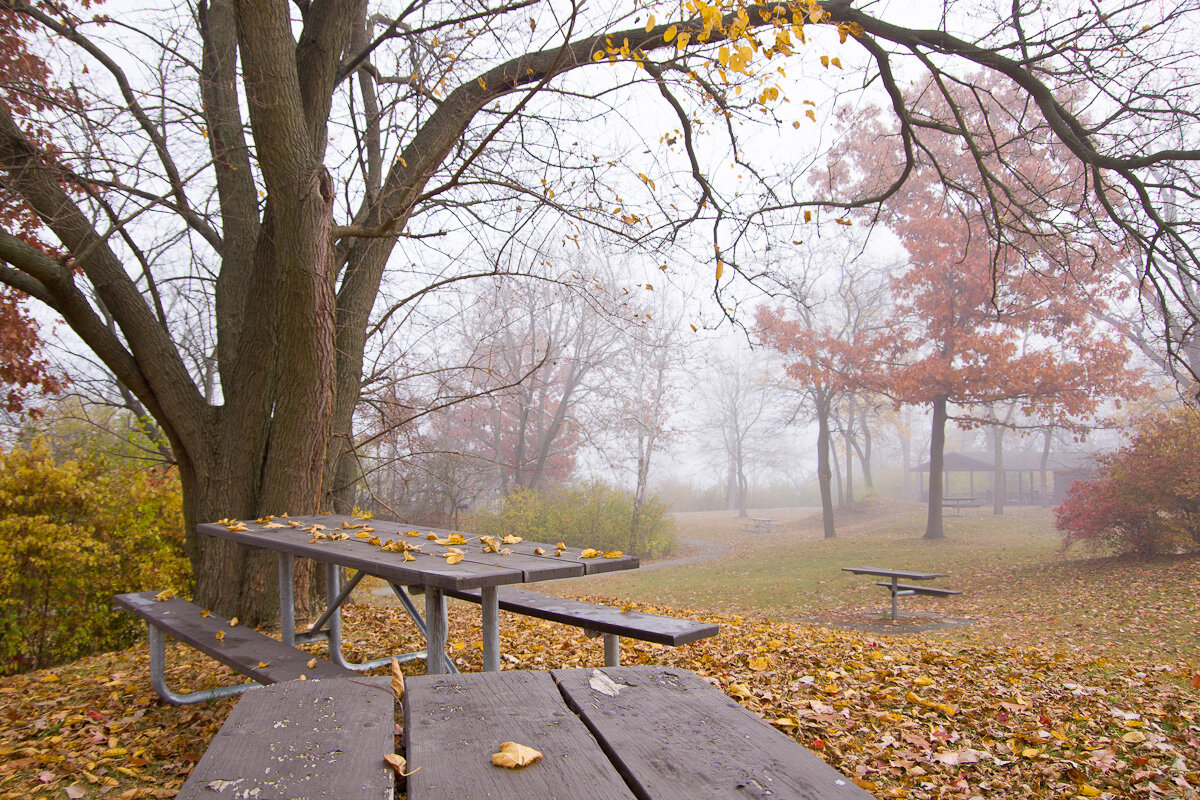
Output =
[{"x1": 551, "y1": 667, "x2": 871, "y2": 800}]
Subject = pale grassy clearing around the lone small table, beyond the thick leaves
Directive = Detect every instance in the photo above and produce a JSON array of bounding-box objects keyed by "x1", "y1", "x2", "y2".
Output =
[{"x1": 556, "y1": 500, "x2": 1200, "y2": 664}]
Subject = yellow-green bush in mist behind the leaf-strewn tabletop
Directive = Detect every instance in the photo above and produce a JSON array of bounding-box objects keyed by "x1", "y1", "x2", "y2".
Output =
[{"x1": 464, "y1": 481, "x2": 674, "y2": 558}]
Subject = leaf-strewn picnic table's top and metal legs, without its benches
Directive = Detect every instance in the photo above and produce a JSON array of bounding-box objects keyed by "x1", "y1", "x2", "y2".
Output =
[{"x1": 196, "y1": 515, "x2": 638, "y2": 674}]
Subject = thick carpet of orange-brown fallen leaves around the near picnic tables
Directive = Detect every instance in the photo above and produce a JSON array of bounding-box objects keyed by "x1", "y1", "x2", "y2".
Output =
[{"x1": 0, "y1": 599, "x2": 1200, "y2": 800}]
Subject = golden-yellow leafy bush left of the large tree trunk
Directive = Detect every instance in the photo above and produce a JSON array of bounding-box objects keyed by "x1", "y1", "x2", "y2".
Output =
[{"x1": 0, "y1": 439, "x2": 190, "y2": 674}]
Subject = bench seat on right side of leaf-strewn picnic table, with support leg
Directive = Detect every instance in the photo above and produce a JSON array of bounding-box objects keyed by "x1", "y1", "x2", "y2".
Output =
[{"x1": 445, "y1": 587, "x2": 720, "y2": 667}]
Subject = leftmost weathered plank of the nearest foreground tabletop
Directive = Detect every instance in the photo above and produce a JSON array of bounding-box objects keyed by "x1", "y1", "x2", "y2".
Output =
[{"x1": 176, "y1": 678, "x2": 395, "y2": 800}]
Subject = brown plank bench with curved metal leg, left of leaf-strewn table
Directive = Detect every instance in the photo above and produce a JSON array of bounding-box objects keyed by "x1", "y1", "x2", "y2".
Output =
[{"x1": 113, "y1": 591, "x2": 358, "y2": 705}]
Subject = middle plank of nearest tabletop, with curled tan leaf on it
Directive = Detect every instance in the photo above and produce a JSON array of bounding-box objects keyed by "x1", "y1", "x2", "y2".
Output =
[{"x1": 403, "y1": 672, "x2": 638, "y2": 800}]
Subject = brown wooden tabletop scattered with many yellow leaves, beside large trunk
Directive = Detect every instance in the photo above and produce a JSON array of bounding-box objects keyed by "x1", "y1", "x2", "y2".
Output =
[{"x1": 196, "y1": 515, "x2": 638, "y2": 589}]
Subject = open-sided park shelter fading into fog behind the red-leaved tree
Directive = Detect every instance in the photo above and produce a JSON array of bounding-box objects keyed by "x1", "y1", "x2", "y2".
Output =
[{"x1": 912, "y1": 451, "x2": 1096, "y2": 505}]
